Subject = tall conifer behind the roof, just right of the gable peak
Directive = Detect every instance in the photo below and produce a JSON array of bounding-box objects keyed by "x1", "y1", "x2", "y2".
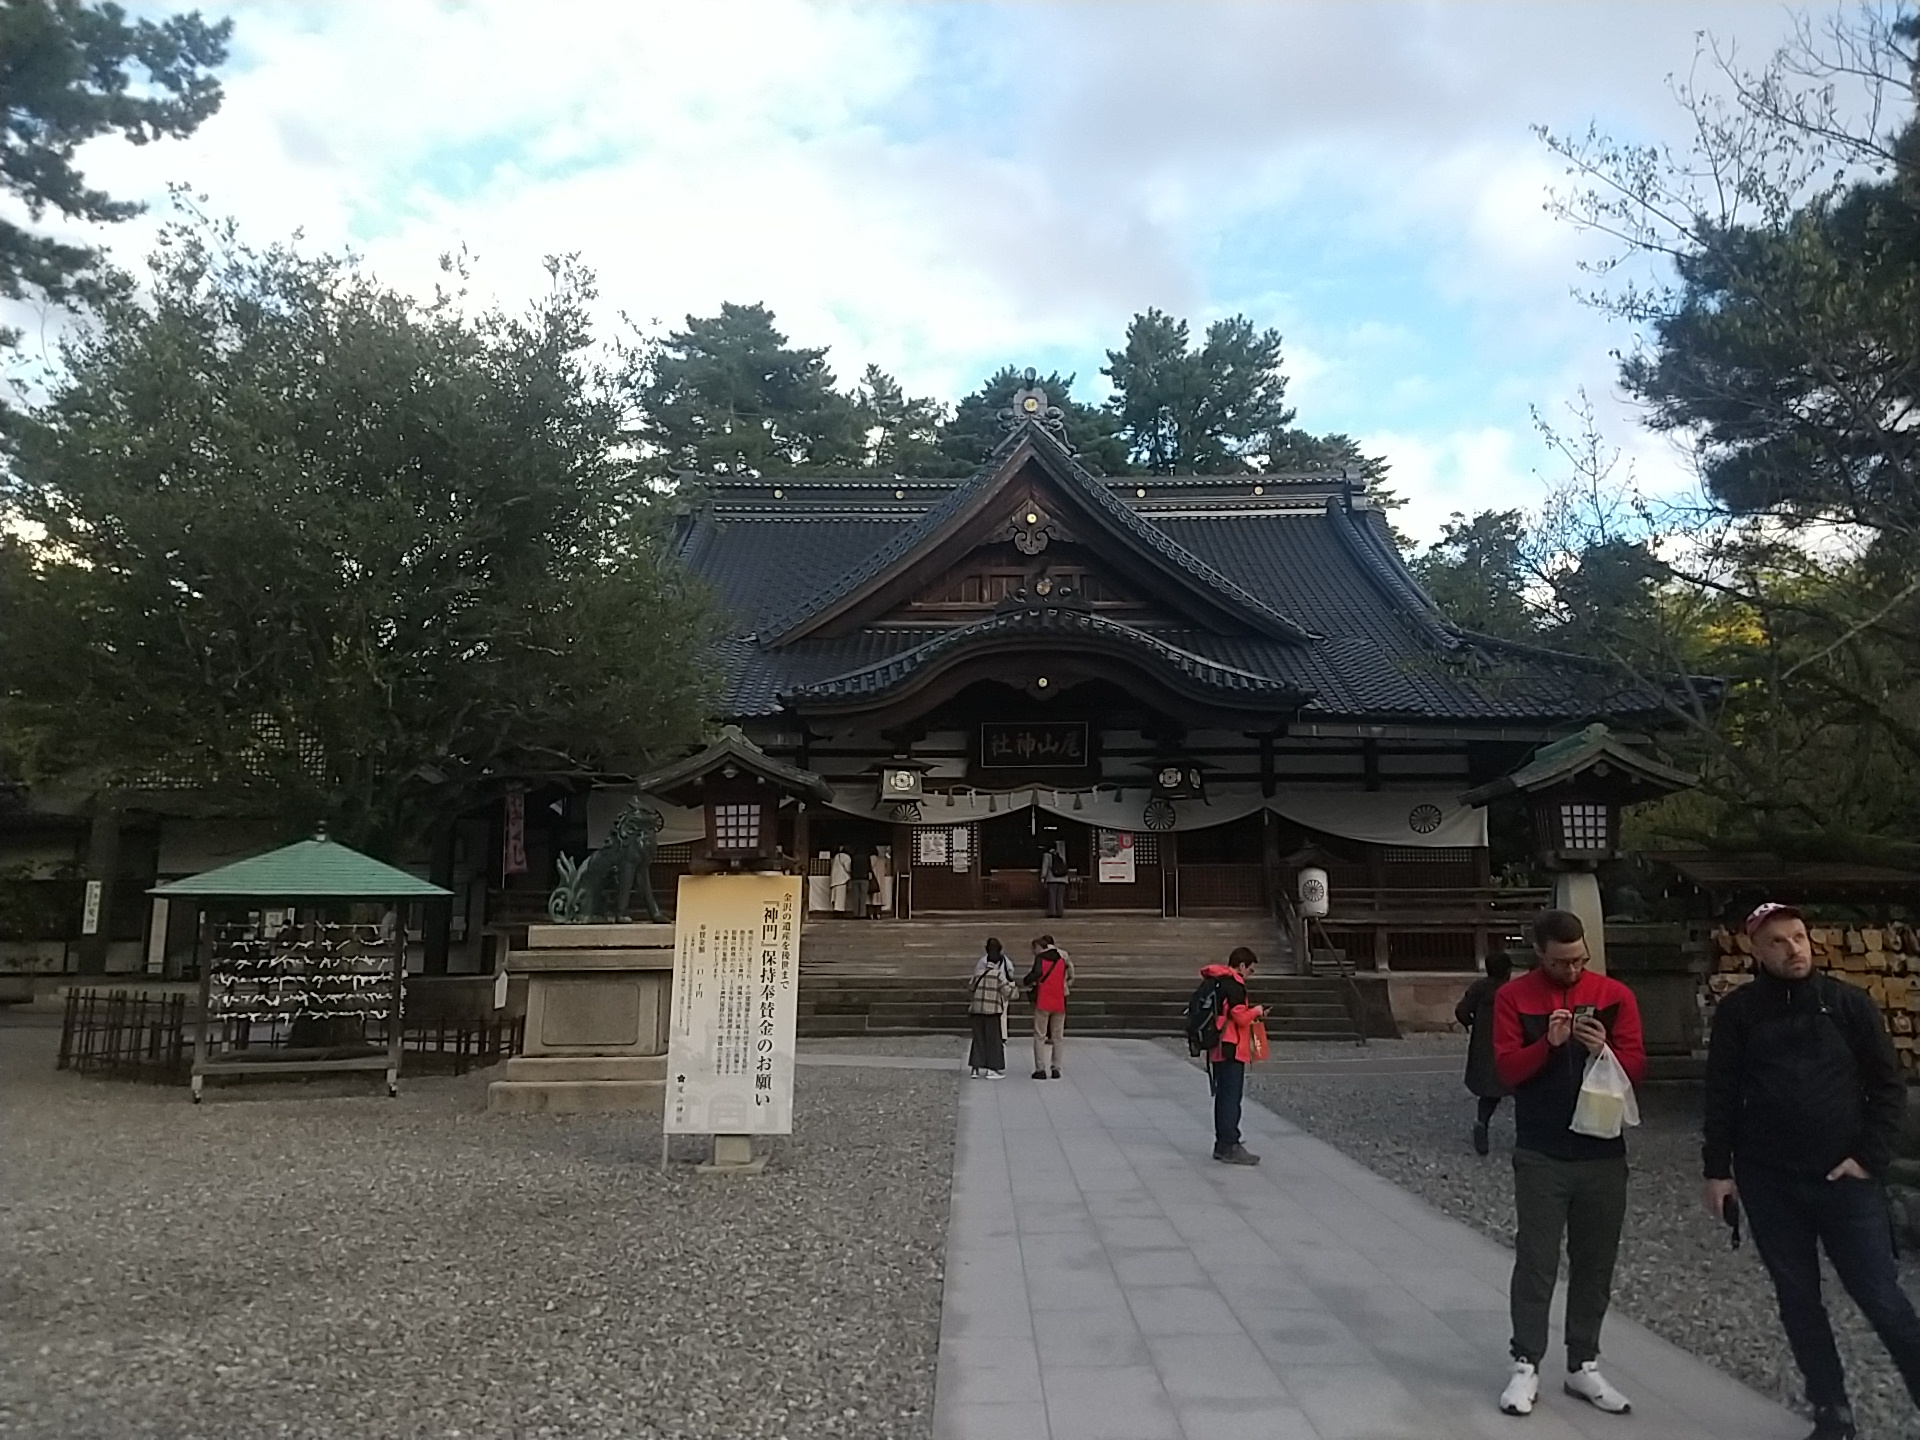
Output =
[{"x1": 1100, "y1": 309, "x2": 1294, "y2": 474}]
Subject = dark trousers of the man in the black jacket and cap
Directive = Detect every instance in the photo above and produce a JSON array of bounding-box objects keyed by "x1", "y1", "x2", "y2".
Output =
[{"x1": 1736, "y1": 1165, "x2": 1920, "y2": 1405}]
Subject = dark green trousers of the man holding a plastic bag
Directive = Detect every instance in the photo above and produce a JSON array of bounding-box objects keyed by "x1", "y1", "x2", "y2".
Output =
[{"x1": 1507, "y1": 1150, "x2": 1626, "y2": 1371}]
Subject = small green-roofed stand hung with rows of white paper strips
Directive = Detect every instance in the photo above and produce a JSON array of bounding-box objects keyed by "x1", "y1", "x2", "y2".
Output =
[{"x1": 148, "y1": 831, "x2": 449, "y2": 1104}]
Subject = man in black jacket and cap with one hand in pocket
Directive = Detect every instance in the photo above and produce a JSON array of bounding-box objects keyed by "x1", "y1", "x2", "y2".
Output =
[{"x1": 1701, "y1": 904, "x2": 1920, "y2": 1440}]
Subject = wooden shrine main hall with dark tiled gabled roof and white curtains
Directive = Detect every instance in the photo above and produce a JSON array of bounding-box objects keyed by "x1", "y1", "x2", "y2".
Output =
[{"x1": 629, "y1": 401, "x2": 1661, "y2": 970}]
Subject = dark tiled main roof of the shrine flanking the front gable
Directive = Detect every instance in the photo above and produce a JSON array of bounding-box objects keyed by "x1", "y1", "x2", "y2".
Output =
[{"x1": 680, "y1": 440, "x2": 1665, "y2": 724}]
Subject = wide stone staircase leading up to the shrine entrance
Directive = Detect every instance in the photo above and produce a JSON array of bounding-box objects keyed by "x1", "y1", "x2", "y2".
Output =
[{"x1": 799, "y1": 910, "x2": 1359, "y2": 1043}]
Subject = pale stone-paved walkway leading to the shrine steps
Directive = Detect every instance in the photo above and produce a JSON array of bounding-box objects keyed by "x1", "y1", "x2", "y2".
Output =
[{"x1": 933, "y1": 1041, "x2": 1807, "y2": 1440}]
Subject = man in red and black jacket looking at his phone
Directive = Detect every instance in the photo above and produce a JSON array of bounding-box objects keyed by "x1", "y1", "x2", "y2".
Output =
[{"x1": 1494, "y1": 910, "x2": 1647, "y2": 1415}]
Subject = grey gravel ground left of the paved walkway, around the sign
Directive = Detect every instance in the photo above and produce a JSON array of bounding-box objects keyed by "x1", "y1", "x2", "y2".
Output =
[{"x1": 0, "y1": 1027, "x2": 956, "y2": 1440}]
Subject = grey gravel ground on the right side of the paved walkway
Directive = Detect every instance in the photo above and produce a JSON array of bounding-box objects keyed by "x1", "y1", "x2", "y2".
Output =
[{"x1": 1228, "y1": 1035, "x2": 1920, "y2": 1440}]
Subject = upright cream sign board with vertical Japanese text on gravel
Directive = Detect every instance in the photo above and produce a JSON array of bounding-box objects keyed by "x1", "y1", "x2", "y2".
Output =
[{"x1": 664, "y1": 876, "x2": 803, "y2": 1135}]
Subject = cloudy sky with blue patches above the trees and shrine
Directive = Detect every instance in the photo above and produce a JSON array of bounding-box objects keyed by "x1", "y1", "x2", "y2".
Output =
[{"x1": 18, "y1": 0, "x2": 1843, "y2": 538}]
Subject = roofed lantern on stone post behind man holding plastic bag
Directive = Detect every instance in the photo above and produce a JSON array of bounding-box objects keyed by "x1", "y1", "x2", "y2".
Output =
[{"x1": 1459, "y1": 726, "x2": 1699, "y2": 973}]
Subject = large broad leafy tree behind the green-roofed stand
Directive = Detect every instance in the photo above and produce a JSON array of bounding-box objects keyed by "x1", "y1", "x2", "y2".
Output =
[{"x1": 0, "y1": 225, "x2": 708, "y2": 854}]
